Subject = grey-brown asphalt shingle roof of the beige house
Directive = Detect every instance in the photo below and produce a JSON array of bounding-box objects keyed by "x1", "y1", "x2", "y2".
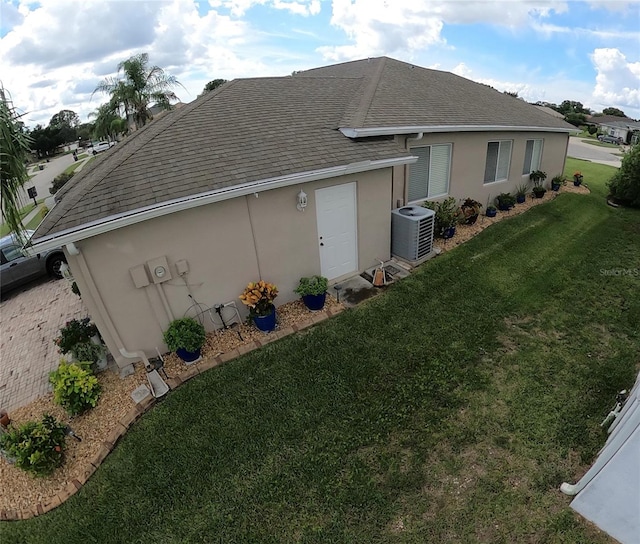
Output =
[{"x1": 35, "y1": 57, "x2": 572, "y2": 239}]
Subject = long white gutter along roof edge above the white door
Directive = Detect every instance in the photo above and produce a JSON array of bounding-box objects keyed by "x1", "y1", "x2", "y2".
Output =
[{"x1": 27, "y1": 156, "x2": 418, "y2": 251}]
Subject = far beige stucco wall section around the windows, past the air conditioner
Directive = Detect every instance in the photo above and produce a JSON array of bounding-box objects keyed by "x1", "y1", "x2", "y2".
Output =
[{"x1": 393, "y1": 132, "x2": 569, "y2": 207}]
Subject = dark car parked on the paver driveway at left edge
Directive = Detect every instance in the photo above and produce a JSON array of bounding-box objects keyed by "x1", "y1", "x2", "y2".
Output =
[{"x1": 0, "y1": 231, "x2": 67, "y2": 291}]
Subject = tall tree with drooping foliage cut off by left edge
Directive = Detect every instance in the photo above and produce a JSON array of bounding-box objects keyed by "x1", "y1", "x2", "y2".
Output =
[{"x1": 0, "y1": 86, "x2": 30, "y2": 237}]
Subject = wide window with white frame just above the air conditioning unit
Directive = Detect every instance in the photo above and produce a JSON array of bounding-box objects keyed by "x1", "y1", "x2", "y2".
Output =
[{"x1": 408, "y1": 144, "x2": 451, "y2": 202}]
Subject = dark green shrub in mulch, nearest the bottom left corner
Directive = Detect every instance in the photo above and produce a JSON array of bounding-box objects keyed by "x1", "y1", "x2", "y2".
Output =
[{"x1": 0, "y1": 414, "x2": 66, "y2": 476}]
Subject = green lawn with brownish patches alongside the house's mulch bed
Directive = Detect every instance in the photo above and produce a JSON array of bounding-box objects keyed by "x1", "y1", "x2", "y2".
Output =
[{"x1": 0, "y1": 159, "x2": 640, "y2": 544}]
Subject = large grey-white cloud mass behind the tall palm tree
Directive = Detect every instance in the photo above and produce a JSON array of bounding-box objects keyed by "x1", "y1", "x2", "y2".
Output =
[{"x1": 0, "y1": 0, "x2": 284, "y2": 126}]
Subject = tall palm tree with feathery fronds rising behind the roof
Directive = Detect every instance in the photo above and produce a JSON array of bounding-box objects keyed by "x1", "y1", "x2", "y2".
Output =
[{"x1": 93, "y1": 53, "x2": 184, "y2": 132}]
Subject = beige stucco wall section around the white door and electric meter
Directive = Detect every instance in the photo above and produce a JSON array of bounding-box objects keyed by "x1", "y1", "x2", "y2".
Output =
[{"x1": 68, "y1": 168, "x2": 392, "y2": 366}]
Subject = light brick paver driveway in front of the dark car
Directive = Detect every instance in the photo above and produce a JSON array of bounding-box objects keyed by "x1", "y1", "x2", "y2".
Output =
[{"x1": 0, "y1": 279, "x2": 88, "y2": 411}]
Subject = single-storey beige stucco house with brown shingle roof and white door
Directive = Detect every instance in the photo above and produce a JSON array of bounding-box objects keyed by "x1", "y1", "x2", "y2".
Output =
[{"x1": 32, "y1": 57, "x2": 575, "y2": 374}]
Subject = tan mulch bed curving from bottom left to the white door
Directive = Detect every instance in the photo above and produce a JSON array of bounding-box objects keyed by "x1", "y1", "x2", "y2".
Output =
[{"x1": 0, "y1": 295, "x2": 342, "y2": 511}]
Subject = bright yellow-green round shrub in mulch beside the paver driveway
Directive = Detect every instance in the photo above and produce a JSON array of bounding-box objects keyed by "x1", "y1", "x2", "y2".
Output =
[{"x1": 49, "y1": 361, "x2": 100, "y2": 416}]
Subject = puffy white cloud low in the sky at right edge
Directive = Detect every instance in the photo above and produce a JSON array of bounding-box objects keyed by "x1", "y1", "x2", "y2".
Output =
[{"x1": 591, "y1": 48, "x2": 640, "y2": 114}]
